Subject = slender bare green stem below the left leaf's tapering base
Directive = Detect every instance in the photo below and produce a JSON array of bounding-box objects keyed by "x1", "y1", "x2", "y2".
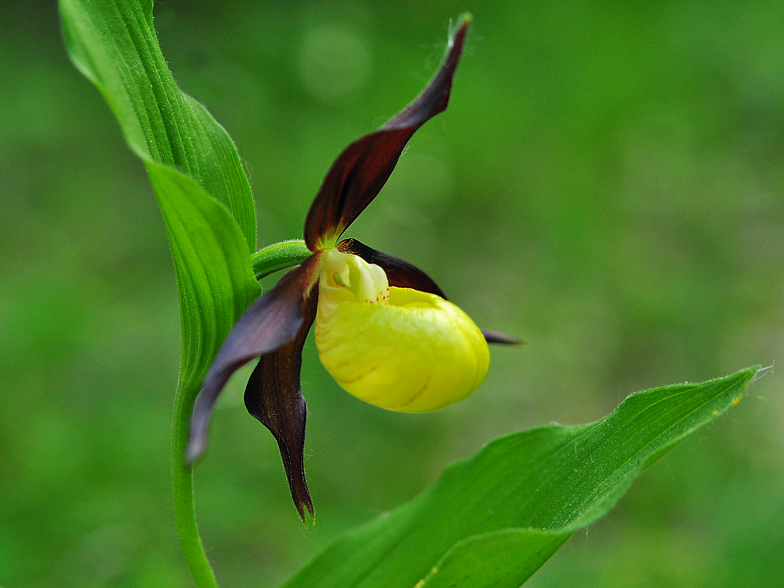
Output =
[{"x1": 172, "y1": 378, "x2": 218, "y2": 588}]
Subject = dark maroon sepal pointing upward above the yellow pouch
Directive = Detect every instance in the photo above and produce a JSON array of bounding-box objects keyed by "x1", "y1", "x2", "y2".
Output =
[{"x1": 305, "y1": 18, "x2": 470, "y2": 251}]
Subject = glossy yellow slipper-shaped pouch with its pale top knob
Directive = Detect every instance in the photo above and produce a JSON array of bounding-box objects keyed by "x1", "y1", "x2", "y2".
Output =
[{"x1": 316, "y1": 249, "x2": 490, "y2": 412}]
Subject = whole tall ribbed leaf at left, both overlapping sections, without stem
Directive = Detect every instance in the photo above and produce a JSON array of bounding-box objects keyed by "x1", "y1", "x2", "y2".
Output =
[{"x1": 60, "y1": 0, "x2": 259, "y2": 394}]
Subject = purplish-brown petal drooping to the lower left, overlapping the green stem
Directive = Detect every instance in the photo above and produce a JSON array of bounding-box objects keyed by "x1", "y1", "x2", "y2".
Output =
[{"x1": 185, "y1": 255, "x2": 320, "y2": 463}]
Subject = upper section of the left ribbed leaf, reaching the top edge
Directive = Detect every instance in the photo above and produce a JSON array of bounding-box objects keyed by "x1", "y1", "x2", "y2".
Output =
[{"x1": 60, "y1": 0, "x2": 256, "y2": 253}]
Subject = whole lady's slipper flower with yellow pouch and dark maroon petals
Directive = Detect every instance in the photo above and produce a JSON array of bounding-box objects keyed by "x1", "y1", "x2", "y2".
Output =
[{"x1": 186, "y1": 17, "x2": 517, "y2": 518}]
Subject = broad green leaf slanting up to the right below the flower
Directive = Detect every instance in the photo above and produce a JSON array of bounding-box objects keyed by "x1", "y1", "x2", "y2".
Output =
[{"x1": 286, "y1": 367, "x2": 758, "y2": 588}]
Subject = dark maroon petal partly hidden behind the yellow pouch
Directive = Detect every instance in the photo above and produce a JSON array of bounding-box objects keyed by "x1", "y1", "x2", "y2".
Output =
[{"x1": 338, "y1": 239, "x2": 522, "y2": 345}]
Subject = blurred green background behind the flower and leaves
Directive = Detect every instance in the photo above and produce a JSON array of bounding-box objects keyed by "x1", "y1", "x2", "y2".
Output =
[{"x1": 0, "y1": 0, "x2": 784, "y2": 588}]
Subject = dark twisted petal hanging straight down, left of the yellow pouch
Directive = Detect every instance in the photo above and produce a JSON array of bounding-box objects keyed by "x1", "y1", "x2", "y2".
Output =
[{"x1": 245, "y1": 289, "x2": 318, "y2": 520}]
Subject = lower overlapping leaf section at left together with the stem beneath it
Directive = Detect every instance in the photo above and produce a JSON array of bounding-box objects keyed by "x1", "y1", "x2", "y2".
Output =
[{"x1": 146, "y1": 162, "x2": 260, "y2": 587}]
